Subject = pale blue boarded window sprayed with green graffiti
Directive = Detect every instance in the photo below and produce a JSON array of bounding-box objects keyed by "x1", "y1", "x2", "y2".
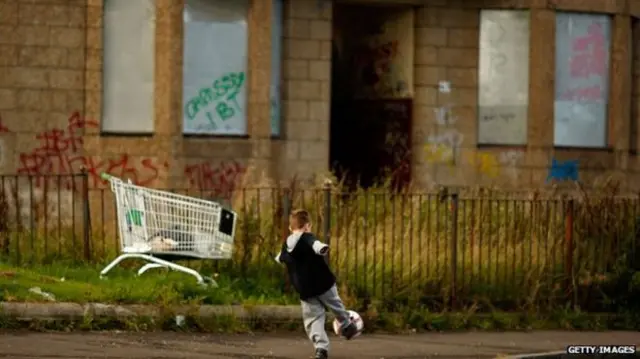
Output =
[{"x1": 183, "y1": 0, "x2": 249, "y2": 135}]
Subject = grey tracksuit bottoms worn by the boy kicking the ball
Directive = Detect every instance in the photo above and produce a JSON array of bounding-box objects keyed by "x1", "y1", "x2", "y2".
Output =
[{"x1": 301, "y1": 285, "x2": 349, "y2": 351}]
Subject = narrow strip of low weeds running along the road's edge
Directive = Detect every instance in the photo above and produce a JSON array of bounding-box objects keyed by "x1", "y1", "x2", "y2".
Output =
[{"x1": 0, "y1": 310, "x2": 640, "y2": 333}]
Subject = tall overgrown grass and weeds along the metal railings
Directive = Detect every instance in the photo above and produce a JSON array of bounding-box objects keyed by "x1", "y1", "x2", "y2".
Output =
[{"x1": 0, "y1": 177, "x2": 640, "y2": 318}]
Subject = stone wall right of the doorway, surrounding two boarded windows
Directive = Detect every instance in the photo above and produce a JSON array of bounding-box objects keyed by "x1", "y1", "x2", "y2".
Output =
[{"x1": 413, "y1": 0, "x2": 639, "y2": 193}]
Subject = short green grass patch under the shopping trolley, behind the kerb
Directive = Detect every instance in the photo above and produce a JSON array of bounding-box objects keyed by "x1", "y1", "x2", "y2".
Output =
[{"x1": 0, "y1": 264, "x2": 298, "y2": 306}]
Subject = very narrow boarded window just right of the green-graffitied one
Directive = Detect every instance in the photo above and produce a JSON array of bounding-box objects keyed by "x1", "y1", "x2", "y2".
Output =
[{"x1": 269, "y1": 0, "x2": 282, "y2": 136}]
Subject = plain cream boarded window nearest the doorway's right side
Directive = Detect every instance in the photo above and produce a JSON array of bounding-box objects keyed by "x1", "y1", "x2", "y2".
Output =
[{"x1": 478, "y1": 10, "x2": 530, "y2": 145}]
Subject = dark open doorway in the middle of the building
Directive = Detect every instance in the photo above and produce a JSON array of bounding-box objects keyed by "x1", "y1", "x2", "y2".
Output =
[{"x1": 330, "y1": 4, "x2": 413, "y2": 191}]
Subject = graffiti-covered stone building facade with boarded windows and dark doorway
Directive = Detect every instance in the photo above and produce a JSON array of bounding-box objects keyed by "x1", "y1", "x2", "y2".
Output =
[{"x1": 0, "y1": 0, "x2": 640, "y2": 197}]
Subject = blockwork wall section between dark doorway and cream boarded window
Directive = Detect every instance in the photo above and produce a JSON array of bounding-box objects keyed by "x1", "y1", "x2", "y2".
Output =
[{"x1": 412, "y1": 7, "x2": 479, "y2": 190}]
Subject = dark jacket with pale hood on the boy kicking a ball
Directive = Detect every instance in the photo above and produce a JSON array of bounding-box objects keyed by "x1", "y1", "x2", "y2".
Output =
[{"x1": 278, "y1": 232, "x2": 336, "y2": 300}]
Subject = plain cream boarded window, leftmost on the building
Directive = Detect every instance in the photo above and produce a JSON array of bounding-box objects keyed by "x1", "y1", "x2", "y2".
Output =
[{"x1": 101, "y1": 0, "x2": 156, "y2": 133}]
